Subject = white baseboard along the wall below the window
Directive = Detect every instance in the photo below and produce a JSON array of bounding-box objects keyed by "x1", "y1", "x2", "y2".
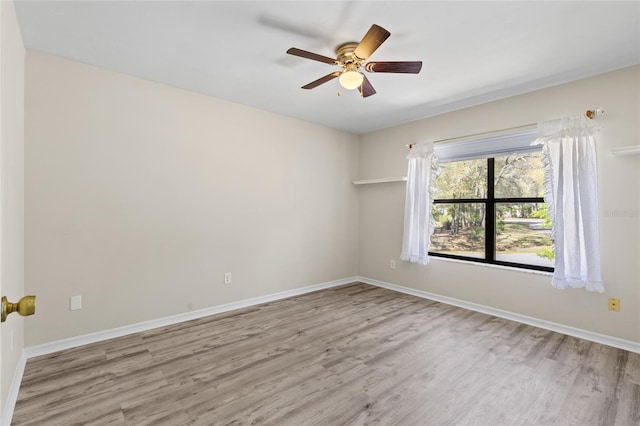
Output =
[{"x1": 358, "y1": 277, "x2": 640, "y2": 353}]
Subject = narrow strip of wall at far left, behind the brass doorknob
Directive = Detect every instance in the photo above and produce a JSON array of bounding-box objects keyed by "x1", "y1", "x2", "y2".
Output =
[{"x1": 0, "y1": 1, "x2": 25, "y2": 418}]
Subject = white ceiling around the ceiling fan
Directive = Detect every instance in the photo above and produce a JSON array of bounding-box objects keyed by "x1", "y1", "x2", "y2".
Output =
[{"x1": 15, "y1": 1, "x2": 640, "y2": 134}]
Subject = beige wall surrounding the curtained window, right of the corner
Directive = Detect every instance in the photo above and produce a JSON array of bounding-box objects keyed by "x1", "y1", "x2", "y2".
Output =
[{"x1": 359, "y1": 66, "x2": 640, "y2": 342}]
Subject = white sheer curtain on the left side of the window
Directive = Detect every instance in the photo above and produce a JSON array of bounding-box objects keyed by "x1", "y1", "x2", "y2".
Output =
[{"x1": 400, "y1": 145, "x2": 436, "y2": 265}]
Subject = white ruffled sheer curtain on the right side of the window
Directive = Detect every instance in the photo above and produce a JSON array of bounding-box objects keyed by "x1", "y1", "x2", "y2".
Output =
[{"x1": 534, "y1": 116, "x2": 604, "y2": 292}]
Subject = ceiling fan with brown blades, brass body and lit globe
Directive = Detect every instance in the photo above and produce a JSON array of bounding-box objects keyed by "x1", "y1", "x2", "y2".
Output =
[{"x1": 287, "y1": 24, "x2": 422, "y2": 98}]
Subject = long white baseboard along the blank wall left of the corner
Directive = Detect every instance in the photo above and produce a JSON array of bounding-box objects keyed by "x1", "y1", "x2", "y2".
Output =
[{"x1": 24, "y1": 277, "x2": 358, "y2": 359}]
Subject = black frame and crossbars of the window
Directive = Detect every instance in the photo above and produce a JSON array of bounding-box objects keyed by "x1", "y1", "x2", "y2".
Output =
[{"x1": 429, "y1": 157, "x2": 554, "y2": 272}]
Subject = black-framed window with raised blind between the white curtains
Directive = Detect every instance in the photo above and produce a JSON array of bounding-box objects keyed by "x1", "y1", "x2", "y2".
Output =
[{"x1": 429, "y1": 132, "x2": 553, "y2": 271}]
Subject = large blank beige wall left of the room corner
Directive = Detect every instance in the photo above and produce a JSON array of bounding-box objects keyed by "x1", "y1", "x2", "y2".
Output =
[{"x1": 25, "y1": 52, "x2": 358, "y2": 346}]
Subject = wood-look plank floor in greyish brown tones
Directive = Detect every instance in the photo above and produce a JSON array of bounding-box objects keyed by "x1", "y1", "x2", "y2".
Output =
[{"x1": 12, "y1": 283, "x2": 640, "y2": 426}]
